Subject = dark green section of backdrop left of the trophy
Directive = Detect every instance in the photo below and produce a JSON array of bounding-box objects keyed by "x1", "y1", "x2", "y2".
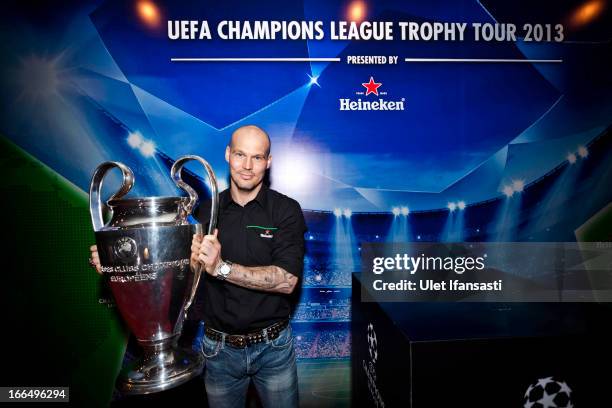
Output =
[{"x1": 0, "y1": 137, "x2": 127, "y2": 407}]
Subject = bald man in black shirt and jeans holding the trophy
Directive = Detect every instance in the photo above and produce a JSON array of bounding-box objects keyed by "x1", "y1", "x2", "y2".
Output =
[{"x1": 191, "y1": 126, "x2": 306, "y2": 408}]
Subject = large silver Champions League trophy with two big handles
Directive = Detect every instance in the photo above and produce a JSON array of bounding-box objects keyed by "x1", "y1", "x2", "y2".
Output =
[{"x1": 89, "y1": 156, "x2": 219, "y2": 394}]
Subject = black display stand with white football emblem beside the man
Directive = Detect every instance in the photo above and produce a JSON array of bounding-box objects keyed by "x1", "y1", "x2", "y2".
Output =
[{"x1": 351, "y1": 274, "x2": 612, "y2": 408}]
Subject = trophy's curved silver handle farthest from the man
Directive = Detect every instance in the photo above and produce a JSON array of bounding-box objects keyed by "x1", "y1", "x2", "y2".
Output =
[{"x1": 89, "y1": 161, "x2": 134, "y2": 232}]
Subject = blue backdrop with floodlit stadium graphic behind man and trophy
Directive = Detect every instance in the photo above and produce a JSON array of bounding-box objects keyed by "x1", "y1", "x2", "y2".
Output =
[{"x1": 0, "y1": 0, "x2": 612, "y2": 404}]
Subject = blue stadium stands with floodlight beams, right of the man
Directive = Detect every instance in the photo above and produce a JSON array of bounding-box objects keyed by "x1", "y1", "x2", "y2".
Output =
[{"x1": 293, "y1": 129, "x2": 612, "y2": 358}]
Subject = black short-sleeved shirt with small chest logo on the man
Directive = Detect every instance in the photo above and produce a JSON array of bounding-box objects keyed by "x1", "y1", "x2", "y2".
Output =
[{"x1": 190, "y1": 185, "x2": 306, "y2": 334}]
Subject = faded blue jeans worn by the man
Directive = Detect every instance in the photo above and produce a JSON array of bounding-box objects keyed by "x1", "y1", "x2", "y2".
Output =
[{"x1": 197, "y1": 325, "x2": 298, "y2": 408}]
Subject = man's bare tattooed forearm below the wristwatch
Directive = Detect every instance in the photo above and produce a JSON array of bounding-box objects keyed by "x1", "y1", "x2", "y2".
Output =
[{"x1": 227, "y1": 264, "x2": 298, "y2": 294}]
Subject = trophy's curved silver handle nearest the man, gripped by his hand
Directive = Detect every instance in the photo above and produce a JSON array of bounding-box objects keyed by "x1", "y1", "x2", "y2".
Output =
[{"x1": 170, "y1": 155, "x2": 219, "y2": 316}]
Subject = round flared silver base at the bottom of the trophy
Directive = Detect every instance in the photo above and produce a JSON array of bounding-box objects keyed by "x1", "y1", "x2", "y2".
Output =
[{"x1": 117, "y1": 348, "x2": 204, "y2": 395}]
